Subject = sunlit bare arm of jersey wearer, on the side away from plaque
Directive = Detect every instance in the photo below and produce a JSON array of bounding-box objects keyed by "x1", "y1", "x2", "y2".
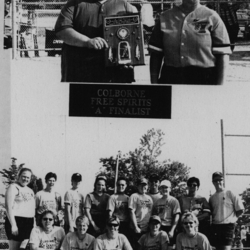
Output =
[{"x1": 215, "y1": 54, "x2": 229, "y2": 85}]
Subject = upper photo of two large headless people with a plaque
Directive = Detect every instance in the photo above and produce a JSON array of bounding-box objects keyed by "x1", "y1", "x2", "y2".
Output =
[{"x1": 1, "y1": 0, "x2": 250, "y2": 82}]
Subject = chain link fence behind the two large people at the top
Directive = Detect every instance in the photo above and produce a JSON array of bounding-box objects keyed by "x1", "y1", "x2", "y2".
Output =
[{"x1": 2, "y1": 0, "x2": 250, "y2": 57}]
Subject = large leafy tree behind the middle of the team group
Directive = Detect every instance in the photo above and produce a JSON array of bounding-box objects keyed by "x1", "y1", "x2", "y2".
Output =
[{"x1": 98, "y1": 129, "x2": 190, "y2": 197}]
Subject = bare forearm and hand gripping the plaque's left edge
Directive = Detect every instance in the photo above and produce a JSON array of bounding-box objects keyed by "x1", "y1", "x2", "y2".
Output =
[{"x1": 56, "y1": 28, "x2": 108, "y2": 50}]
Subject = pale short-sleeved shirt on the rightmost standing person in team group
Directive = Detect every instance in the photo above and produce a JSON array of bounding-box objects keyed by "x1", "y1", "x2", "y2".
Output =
[{"x1": 209, "y1": 190, "x2": 244, "y2": 224}]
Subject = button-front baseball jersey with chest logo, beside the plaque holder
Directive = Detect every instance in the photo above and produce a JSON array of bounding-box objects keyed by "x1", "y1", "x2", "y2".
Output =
[{"x1": 149, "y1": 6, "x2": 231, "y2": 68}]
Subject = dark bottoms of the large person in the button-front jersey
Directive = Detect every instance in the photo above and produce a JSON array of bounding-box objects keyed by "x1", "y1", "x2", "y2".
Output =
[{"x1": 158, "y1": 64, "x2": 217, "y2": 85}]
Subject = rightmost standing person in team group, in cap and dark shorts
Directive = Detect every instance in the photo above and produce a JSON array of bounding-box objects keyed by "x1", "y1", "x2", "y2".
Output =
[{"x1": 209, "y1": 172, "x2": 244, "y2": 250}]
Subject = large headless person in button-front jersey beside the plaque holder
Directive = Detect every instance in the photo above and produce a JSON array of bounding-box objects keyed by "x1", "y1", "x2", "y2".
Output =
[{"x1": 149, "y1": 0, "x2": 231, "y2": 85}]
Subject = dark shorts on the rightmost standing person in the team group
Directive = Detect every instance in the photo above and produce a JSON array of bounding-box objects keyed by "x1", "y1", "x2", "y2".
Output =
[{"x1": 211, "y1": 223, "x2": 235, "y2": 247}]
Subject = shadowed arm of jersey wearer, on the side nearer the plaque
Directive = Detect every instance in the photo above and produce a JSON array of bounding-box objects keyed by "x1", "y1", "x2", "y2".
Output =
[{"x1": 150, "y1": 50, "x2": 163, "y2": 83}]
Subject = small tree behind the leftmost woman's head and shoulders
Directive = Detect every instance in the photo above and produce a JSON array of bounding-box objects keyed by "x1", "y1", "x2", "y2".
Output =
[{"x1": 0, "y1": 157, "x2": 43, "y2": 196}]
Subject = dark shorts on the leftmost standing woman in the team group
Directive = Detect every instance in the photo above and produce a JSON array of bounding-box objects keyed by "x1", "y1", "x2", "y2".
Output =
[{"x1": 5, "y1": 216, "x2": 34, "y2": 242}]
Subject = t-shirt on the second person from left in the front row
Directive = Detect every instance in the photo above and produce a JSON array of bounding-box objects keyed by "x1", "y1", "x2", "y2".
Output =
[{"x1": 60, "y1": 232, "x2": 95, "y2": 250}]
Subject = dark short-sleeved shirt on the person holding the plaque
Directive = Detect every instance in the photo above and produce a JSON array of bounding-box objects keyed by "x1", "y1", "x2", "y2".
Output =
[{"x1": 55, "y1": 0, "x2": 136, "y2": 82}]
